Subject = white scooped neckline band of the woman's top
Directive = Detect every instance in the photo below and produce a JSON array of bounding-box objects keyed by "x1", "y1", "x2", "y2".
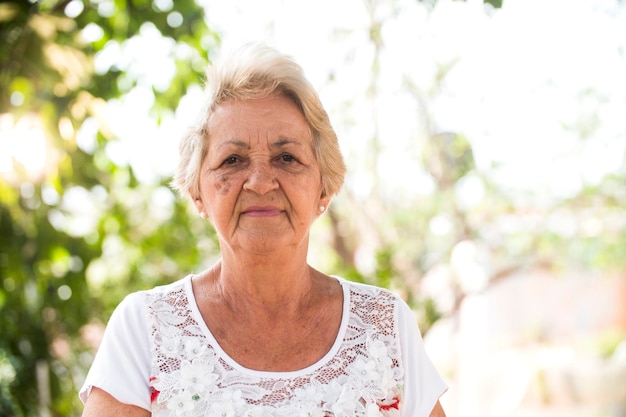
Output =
[{"x1": 184, "y1": 275, "x2": 350, "y2": 378}]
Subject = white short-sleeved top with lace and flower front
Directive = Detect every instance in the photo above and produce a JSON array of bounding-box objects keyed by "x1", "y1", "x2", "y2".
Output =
[{"x1": 80, "y1": 276, "x2": 447, "y2": 417}]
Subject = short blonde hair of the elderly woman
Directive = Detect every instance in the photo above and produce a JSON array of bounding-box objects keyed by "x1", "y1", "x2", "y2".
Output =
[{"x1": 171, "y1": 44, "x2": 346, "y2": 200}]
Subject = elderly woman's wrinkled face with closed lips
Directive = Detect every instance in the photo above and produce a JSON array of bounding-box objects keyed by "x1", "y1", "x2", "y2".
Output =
[{"x1": 195, "y1": 96, "x2": 329, "y2": 253}]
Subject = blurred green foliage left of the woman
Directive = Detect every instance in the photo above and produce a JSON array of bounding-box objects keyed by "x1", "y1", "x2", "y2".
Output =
[{"x1": 0, "y1": 0, "x2": 219, "y2": 416}]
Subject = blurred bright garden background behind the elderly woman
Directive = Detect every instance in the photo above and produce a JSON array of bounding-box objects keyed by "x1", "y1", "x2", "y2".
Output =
[{"x1": 0, "y1": 0, "x2": 626, "y2": 417}]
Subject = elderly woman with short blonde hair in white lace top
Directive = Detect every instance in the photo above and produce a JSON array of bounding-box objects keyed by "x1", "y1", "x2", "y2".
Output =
[{"x1": 80, "y1": 46, "x2": 446, "y2": 417}]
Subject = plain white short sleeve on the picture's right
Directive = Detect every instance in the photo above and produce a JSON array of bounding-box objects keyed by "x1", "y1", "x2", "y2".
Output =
[{"x1": 398, "y1": 301, "x2": 448, "y2": 417}]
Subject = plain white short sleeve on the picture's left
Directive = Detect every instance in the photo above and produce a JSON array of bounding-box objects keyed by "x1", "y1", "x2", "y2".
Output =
[{"x1": 79, "y1": 293, "x2": 151, "y2": 410}]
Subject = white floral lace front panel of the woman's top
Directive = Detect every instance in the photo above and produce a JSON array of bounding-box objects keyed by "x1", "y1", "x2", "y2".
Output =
[{"x1": 147, "y1": 283, "x2": 403, "y2": 417}]
